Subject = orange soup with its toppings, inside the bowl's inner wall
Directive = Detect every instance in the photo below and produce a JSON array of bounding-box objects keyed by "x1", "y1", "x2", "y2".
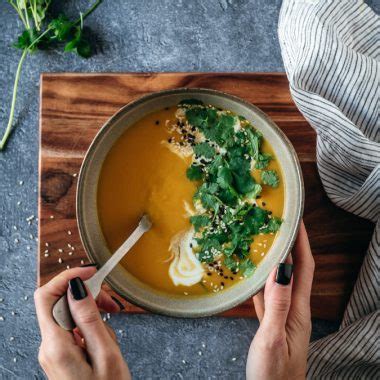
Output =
[{"x1": 97, "y1": 102, "x2": 284, "y2": 296}]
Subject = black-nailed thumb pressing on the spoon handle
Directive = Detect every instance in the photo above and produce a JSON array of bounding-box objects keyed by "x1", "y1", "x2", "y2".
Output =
[{"x1": 67, "y1": 277, "x2": 112, "y2": 358}]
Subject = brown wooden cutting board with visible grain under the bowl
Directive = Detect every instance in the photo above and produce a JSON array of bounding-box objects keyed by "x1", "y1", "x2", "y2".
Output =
[{"x1": 38, "y1": 73, "x2": 373, "y2": 320}]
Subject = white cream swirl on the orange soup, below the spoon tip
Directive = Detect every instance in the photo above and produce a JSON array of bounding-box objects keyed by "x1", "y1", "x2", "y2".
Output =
[{"x1": 169, "y1": 228, "x2": 204, "y2": 286}]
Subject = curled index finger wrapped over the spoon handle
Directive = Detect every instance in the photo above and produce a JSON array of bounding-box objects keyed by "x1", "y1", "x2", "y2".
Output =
[{"x1": 34, "y1": 267, "x2": 95, "y2": 338}]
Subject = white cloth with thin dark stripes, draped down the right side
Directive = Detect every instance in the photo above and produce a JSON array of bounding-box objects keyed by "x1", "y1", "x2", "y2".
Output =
[{"x1": 278, "y1": 0, "x2": 380, "y2": 379}]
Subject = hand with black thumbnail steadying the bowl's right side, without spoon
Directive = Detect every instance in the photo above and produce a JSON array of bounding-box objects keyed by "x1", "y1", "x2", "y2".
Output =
[{"x1": 247, "y1": 222, "x2": 314, "y2": 380}]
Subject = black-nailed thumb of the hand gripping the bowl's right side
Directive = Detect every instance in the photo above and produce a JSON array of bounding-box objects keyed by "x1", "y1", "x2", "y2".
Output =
[{"x1": 262, "y1": 259, "x2": 293, "y2": 333}]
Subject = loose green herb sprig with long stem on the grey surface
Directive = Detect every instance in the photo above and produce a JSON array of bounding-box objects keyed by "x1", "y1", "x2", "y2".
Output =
[{"x1": 0, "y1": 0, "x2": 102, "y2": 150}]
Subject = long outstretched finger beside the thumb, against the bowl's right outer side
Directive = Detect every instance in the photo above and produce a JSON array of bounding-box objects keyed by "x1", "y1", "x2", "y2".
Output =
[{"x1": 292, "y1": 222, "x2": 315, "y2": 313}]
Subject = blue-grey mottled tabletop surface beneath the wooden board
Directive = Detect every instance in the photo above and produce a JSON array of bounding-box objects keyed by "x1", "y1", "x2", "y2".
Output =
[{"x1": 0, "y1": 0, "x2": 380, "y2": 379}]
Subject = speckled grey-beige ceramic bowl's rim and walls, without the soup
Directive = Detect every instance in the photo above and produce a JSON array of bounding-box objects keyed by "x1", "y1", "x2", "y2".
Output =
[{"x1": 77, "y1": 88, "x2": 304, "y2": 317}]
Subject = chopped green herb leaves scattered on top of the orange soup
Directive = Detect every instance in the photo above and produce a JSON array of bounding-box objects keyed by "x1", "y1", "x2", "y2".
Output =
[{"x1": 178, "y1": 99, "x2": 281, "y2": 277}]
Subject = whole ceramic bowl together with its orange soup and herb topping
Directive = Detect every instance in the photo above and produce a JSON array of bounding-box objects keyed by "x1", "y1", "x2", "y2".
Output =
[{"x1": 77, "y1": 88, "x2": 304, "y2": 317}]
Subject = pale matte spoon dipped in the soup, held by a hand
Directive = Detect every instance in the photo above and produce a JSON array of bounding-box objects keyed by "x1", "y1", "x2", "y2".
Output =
[{"x1": 53, "y1": 215, "x2": 152, "y2": 330}]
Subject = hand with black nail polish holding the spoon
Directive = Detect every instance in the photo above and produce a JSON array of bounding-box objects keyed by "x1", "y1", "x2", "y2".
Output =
[{"x1": 34, "y1": 267, "x2": 131, "y2": 380}]
